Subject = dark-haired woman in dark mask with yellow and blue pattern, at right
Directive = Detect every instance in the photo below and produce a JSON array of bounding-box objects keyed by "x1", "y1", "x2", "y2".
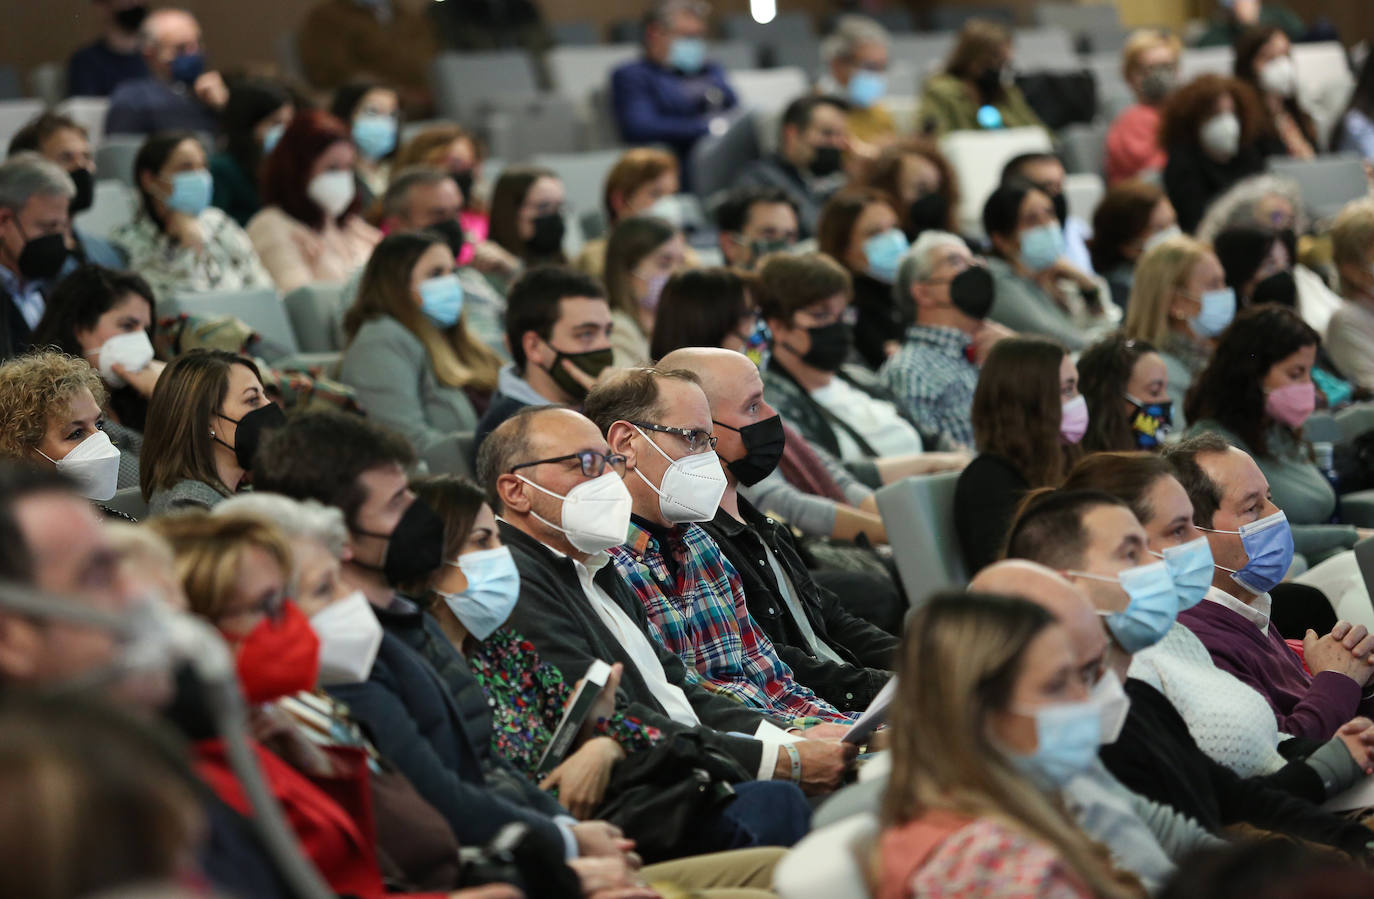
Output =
[{"x1": 1079, "y1": 333, "x2": 1173, "y2": 450}]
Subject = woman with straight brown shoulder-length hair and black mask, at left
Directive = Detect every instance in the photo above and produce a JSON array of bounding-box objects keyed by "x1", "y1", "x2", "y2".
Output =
[{"x1": 139, "y1": 351, "x2": 284, "y2": 515}]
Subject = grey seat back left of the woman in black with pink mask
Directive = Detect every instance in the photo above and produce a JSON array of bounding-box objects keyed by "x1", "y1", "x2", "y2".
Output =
[{"x1": 875, "y1": 471, "x2": 969, "y2": 609}]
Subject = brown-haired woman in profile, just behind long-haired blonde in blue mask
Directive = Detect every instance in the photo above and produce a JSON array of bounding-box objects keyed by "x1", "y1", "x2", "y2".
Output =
[{"x1": 1091, "y1": 179, "x2": 1179, "y2": 313}]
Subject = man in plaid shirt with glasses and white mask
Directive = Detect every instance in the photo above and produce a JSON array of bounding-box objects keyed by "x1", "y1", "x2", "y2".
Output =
[{"x1": 585, "y1": 368, "x2": 849, "y2": 723}]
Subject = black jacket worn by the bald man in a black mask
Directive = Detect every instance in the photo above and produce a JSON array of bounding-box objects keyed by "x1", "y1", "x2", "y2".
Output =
[{"x1": 701, "y1": 496, "x2": 900, "y2": 712}]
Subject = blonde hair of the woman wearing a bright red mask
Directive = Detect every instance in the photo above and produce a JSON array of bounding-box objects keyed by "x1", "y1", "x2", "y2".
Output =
[{"x1": 146, "y1": 511, "x2": 295, "y2": 621}]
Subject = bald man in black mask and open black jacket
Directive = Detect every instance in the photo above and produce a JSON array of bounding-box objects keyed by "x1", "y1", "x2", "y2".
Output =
[{"x1": 660, "y1": 346, "x2": 899, "y2": 709}]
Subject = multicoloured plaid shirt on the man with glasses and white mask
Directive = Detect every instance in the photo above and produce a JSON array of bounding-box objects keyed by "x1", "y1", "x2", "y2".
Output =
[{"x1": 610, "y1": 520, "x2": 852, "y2": 724}]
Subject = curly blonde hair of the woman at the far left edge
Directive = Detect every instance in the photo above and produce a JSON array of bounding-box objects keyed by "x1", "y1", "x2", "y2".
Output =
[{"x1": 0, "y1": 349, "x2": 107, "y2": 459}]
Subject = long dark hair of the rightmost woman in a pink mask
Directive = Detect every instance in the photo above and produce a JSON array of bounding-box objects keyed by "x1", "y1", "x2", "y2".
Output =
[{"x1": 1183, "y1": 305, "x2": 1322, "y2": 456}]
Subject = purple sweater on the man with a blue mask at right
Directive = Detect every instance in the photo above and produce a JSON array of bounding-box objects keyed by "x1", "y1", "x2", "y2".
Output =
[{"x1": 1179, "y1": 599, "x2": 1360, "y2": 740}]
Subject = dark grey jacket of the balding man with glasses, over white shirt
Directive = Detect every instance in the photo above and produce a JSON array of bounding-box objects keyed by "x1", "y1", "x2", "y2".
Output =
[{"x1": 500, "y1": 522, "x2": 786, "y2": 771}]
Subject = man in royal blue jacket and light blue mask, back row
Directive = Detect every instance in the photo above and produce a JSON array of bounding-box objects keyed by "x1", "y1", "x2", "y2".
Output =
[{"x1": 610, "y1": 0, "x2": 738, "y2": 159}]
